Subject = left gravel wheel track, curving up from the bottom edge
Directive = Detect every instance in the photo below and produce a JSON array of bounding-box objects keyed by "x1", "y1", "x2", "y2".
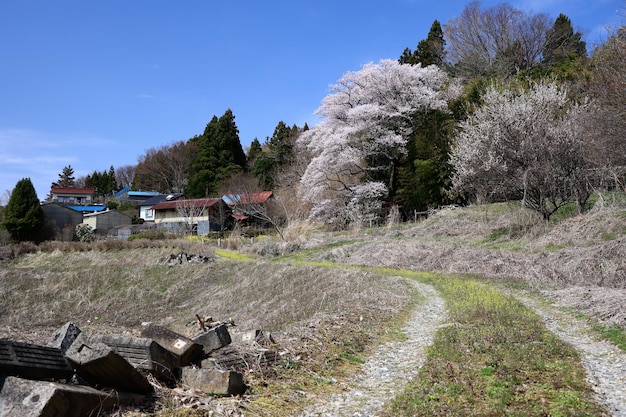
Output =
[{"x1": 300, "y1": 281, "x2": 446, "y2": 417}]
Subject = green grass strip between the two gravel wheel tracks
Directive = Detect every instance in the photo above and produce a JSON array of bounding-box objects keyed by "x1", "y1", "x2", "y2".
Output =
[{"x1": 384, "y1": 276, "x2": 606, "y2": 416}]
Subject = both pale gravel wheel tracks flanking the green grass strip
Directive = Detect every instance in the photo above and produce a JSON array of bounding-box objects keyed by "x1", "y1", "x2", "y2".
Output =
[{"x1": 300, "y1": 281, "x2": 626, "y2": 417}]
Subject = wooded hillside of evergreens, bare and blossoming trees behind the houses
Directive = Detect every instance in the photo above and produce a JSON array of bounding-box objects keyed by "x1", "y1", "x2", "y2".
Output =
[{"x1": 13, "y1": 1, "x2": 626, "y2": 228}]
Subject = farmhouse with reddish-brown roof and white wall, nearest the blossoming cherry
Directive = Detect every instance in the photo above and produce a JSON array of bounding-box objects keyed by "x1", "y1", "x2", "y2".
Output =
[{"x1": 152, "y1": 198, "x2": 229, "y2": 235}]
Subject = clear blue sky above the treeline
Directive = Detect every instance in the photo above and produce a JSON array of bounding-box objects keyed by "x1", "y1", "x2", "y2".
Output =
[{"x1": 0, "y1": 0, "x2": 625, "y2": 203}]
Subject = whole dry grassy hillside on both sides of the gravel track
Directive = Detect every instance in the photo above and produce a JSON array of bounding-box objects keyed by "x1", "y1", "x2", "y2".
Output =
[{"x1": 0, "y1": 197, "x2": 626, "y2": 416}]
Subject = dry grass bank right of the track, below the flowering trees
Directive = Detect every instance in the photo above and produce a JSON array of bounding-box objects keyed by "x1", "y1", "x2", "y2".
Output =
[{"x1": 270, "y1": 199, "x2": 626, "y2": 328}]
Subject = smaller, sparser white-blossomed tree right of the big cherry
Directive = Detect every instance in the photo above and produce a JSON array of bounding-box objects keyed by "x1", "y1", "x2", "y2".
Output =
[{"x1": 450, "y1": 82, "x2": 590, "y2": 220}]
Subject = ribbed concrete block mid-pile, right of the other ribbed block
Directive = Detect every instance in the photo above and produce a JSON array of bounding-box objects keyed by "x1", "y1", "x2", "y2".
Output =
[{"x1": 89, "y1": 335, "x2": 180, "y2": 381}]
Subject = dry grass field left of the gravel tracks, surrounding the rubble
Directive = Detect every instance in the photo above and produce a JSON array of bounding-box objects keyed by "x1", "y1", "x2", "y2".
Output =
[{"x1": 0, "y1": 239, "x2": 414, "y2": 416}]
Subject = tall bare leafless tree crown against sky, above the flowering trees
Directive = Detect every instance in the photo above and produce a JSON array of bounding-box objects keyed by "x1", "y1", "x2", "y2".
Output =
[{"x1": 444, "y1": 1, "x2": 550, "y2": 77}]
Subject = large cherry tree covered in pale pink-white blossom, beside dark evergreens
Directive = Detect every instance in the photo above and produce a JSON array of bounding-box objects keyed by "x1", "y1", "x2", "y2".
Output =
[{"x1": 298, "y1": 60, "x2": 447, "y2": 225}]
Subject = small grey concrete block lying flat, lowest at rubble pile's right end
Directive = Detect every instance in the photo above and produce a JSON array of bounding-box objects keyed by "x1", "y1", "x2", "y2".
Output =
[{"x1": 181, "y1": 366, "x2": 247, "y2": 395}]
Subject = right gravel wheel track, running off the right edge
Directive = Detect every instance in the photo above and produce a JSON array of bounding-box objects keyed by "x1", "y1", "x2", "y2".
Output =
[{"x1": 515, "y1": 294, "x2": 626, "y2": 417}]
